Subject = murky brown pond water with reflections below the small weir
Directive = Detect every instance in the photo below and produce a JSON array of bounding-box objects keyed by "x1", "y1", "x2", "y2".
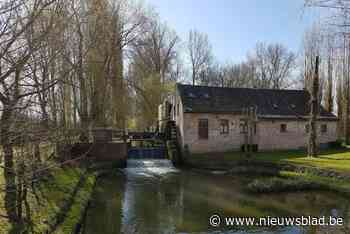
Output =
[{"x1": 85, "y1": 161, "x2": 350, "y2": 234}]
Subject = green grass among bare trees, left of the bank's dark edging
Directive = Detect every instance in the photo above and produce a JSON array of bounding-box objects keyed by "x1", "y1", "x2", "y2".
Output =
[{"x1": 0, "y1": 167, "x2": 91, "y2": 233}]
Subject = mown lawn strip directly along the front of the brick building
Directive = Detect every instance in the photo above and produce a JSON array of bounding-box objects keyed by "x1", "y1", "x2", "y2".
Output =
[{"x1": 186, "y1": 148, "x2": 350, "y2": 173}]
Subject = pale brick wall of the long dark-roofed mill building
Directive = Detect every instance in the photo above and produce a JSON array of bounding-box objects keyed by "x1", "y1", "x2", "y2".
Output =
[{"x1": 176, "y1": 113, "x2": 337, "y2": 153}]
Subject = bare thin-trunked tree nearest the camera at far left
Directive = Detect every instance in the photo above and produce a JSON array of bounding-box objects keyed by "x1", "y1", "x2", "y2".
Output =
[{"x1": 0, "y1": 0, "x2": 61, "y2": 221}]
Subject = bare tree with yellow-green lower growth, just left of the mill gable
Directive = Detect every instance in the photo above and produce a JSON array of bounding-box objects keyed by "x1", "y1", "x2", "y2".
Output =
[{"x1": 128, "y1": 19, "x2": 179, "y2": 129}]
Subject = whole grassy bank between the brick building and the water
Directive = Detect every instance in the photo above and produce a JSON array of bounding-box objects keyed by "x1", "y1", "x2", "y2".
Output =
[{"x1": 186, "y1": 148, "x2": 350, "y2": 195}]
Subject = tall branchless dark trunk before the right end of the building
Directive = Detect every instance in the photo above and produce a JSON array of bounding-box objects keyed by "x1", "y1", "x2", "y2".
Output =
[{"x1": 308, "y1": 56, "x2": 319, "y2": 157}]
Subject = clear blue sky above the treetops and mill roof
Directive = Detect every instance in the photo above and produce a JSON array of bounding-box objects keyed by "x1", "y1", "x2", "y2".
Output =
[{"x1": 145, "y1": 0, "x2": 317, "y2": 62}]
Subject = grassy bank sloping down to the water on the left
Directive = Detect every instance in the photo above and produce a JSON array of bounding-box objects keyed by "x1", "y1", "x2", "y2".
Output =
[{"x1": 0, "y1": 167, "x2": 95, "y2": 233}]
